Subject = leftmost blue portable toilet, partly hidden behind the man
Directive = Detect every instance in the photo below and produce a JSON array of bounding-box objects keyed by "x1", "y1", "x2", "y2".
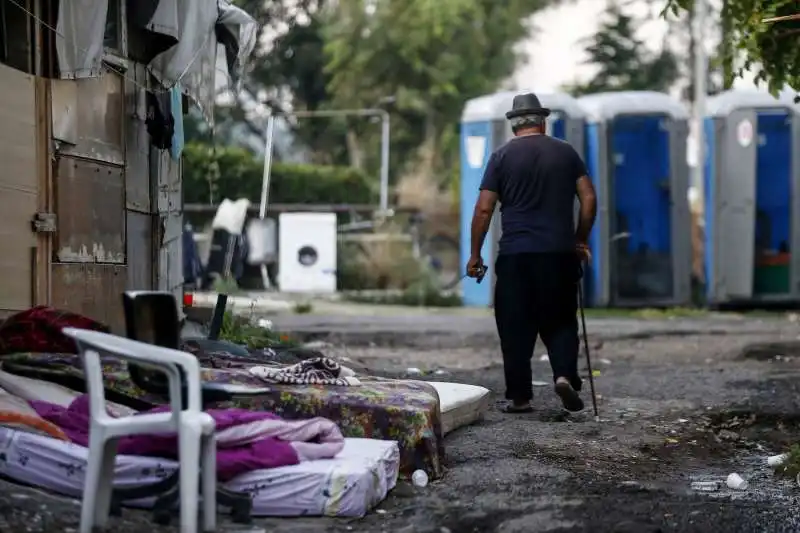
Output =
[{"x1": 460, "y1": 90, "x2": 584, "y2": 307}]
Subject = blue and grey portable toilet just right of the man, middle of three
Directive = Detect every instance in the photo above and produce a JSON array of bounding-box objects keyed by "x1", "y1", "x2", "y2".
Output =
[{"x1": 578, "y1": 91, "x2": 692, "y2": 307}]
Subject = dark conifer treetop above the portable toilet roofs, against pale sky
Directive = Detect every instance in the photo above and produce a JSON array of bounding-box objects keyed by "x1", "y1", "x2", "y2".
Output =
[{"x1": 568, "y1": 3, "x2": 680, "y2": 95}]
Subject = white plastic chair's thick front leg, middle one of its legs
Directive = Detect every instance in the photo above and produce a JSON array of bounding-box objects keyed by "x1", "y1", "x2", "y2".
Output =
[{"x1": 178, "y1": 417, "x2": 202, "y2": 533}]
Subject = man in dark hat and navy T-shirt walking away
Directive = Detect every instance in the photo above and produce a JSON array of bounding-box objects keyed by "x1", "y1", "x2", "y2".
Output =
[{"x1": 467, "y1": 93, "x2": 597, "y2": 413}]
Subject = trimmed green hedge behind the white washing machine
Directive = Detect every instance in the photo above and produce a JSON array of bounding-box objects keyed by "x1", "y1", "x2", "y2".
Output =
[{"x1": 183, "y1": 143, "x2": 377, "y2": 204}]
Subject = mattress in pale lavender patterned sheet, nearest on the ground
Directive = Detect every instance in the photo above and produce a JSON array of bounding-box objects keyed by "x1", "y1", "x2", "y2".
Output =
[{"x1": 0, "y1": 427, "x2": 400, "y2": 517}]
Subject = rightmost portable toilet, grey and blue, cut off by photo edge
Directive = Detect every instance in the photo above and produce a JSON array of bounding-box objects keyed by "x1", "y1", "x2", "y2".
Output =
[{"x1": 703, "y1": 90, "x2": 800, "y2": 306}]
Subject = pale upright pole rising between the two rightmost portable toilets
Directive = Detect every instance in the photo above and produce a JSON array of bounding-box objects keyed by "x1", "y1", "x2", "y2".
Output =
[{"x1": 692, "y1": 0, "x2": 708, "y2": 193}]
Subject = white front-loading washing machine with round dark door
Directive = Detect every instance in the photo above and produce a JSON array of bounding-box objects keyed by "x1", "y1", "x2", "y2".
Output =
[{"x1": 278, "y1": 213, "x2": 336, "y2": 293}]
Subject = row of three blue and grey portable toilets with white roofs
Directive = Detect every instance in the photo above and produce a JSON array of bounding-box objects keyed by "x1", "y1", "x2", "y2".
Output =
[{"x1": 461, "y1": 91, "x2": 800, "y2": 307}]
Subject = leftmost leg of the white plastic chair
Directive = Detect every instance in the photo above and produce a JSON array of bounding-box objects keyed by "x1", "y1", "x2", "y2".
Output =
[{"x1": 80, "y1": 427, "x2": 117, "y2": 533}]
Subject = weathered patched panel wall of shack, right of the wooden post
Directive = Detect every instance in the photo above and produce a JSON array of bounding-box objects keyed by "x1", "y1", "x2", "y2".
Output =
[{"x1": 51, "y1": 64, "x2": 183, "y2": 330}]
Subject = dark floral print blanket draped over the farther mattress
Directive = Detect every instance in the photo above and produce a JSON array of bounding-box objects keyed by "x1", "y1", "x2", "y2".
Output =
[{"x1": 2, "y1": 353, "x2": 444, "y2": 479}]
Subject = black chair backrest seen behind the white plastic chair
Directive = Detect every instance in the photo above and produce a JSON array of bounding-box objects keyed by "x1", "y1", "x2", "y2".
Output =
[{"x1": 122, "y1": 291, "x2": 180, "y2": 395}]
